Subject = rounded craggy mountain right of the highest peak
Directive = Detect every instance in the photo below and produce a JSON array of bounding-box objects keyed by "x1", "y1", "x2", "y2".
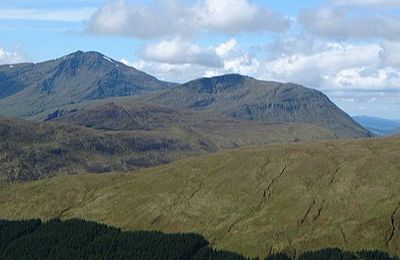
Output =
[{"x1": 146, "y1": 74, "x2": 370, "y2": 137}]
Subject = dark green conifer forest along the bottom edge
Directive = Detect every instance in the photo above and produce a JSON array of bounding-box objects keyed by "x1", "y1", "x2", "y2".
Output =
[{"x1": 0, "y1": 219, "x2": 398, "y2": 260}]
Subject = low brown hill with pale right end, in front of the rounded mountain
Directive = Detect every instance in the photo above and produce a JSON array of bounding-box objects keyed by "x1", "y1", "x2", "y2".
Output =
[{"x1": 56, "y1": 101, "x2": 337, "y2": 144}]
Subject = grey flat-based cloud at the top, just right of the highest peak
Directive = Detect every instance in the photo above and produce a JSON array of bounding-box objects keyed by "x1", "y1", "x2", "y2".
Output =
[{"x1": 88, "y1": 0, "x2": 194, "y2": 39}]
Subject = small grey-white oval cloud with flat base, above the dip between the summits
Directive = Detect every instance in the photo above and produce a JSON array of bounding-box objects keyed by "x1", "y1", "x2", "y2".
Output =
[{"x1": 141, "y1": 38, "x2": 222, "y2": 67}]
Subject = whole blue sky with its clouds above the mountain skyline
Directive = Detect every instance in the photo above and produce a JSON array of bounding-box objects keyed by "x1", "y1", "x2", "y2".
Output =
[{"x1": 0, "y1": 0, "x2": 400, "y2": 119}]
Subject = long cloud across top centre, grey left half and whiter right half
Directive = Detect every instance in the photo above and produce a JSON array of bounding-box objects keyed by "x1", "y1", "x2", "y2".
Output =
[{"x1": 88, "y1": 0, "x2": 290, "y2": 39}]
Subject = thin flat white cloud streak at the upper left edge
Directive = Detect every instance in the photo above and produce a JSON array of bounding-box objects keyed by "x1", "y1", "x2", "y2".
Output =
[{"x1": 0, "y1": 8, "x2": 96, "y2": 22}]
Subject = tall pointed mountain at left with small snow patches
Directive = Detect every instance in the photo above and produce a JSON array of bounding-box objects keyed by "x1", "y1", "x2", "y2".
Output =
[{"x1": 0, "y1": 51, "x2": 175, "y2": 117}]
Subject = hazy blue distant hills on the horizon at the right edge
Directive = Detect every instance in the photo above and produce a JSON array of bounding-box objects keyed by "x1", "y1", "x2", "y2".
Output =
[{"x1": 353, "y1": 116, "x2": 400, "y2": 135}]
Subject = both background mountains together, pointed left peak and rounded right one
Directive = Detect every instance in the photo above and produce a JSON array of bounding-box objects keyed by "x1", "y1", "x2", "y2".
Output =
[{"x1": 0, "y1": 51, "x2": 371, "y2": 138}]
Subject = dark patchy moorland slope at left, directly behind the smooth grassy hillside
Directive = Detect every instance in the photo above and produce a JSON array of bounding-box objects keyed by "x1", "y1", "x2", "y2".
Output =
[{"x1": 0, "y1": 119, "x2": 206, "y2": 182}]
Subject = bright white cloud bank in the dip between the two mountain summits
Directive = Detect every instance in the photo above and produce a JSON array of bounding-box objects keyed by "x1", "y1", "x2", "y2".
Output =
[{"x1": 125, "y1": 39, "x2": 260, "y2": 82}]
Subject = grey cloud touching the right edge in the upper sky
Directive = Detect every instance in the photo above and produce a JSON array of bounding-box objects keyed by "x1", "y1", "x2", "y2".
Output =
[{"x1": 298, "y1": 7, "x2": 400, "y2": 40}]
